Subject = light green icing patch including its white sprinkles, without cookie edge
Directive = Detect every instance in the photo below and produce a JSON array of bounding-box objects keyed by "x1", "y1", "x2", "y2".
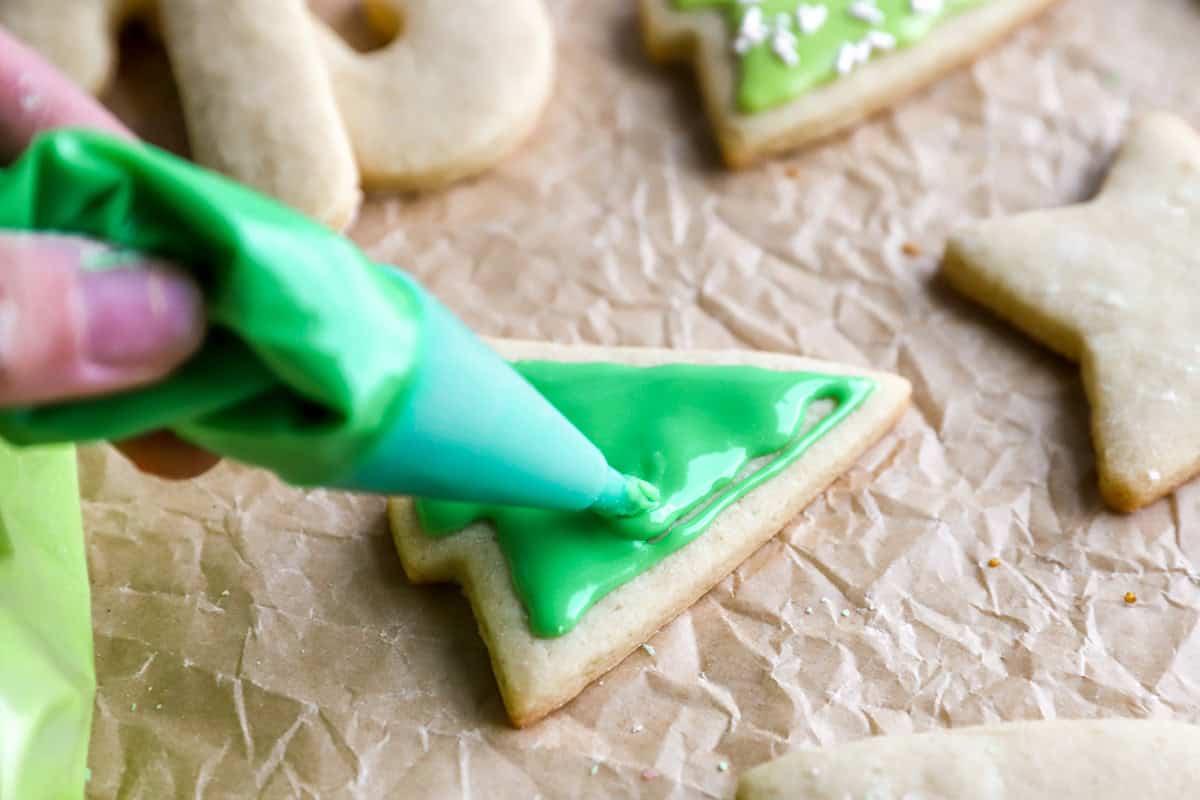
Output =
[{"x1": 673, "y1": 0, "x2": 983, "y2": 113}]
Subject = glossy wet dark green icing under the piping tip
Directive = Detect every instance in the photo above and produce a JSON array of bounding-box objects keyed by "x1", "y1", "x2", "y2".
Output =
[{"x1": 416, "y1": 361, "x2": 875, "y2": 637}]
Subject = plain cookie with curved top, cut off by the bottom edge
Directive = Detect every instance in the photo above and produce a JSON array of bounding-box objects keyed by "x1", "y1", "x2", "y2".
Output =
[{"x1": 738, "y1": 720, "x2": 1200, "y2": 800}]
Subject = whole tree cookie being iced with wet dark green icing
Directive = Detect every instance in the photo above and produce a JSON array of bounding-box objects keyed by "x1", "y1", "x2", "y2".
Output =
[{"x1": 391, "y1": 342, "x2": 910, "y2": 726}]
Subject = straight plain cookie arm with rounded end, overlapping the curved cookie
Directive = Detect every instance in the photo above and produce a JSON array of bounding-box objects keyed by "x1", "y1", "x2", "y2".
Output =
[{"x1": 158, "y1": 0, "x2": 360, "y2": 229}]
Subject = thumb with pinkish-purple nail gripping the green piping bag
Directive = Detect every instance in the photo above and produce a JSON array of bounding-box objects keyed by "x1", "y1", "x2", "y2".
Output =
[{"x1": 0, "y1": 234, "x2": 204, "y2": 408}]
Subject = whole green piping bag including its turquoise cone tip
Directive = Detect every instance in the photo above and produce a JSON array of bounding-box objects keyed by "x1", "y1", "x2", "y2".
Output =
[{"x1": 0, "y1": 131, "x2": 658, "y2": 525}]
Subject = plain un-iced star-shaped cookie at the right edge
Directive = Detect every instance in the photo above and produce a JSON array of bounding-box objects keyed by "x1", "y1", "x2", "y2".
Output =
[{"x1": 942, "y1": 114, "x2": 1200, "y2": 511}]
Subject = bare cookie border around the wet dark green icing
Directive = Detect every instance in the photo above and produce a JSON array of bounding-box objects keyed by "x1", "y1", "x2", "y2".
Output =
[{"x1": 390, "y1": 342, "x2": 911, "y2": 727}]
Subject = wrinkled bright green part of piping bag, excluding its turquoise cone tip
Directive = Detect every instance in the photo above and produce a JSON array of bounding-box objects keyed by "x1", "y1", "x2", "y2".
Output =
[{"x1": 0, "y1": 131, "x2": 422, "y2": 485}]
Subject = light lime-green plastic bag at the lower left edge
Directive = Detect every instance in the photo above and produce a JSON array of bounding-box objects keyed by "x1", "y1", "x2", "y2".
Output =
[{"x1": 0, "y1": 441, "x2": 96, "y2": 800}]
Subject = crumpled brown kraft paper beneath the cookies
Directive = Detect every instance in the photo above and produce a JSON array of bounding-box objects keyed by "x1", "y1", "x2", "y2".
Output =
[{"x1": 80, "y1": 0, "x2": 1200, "y2": 799}]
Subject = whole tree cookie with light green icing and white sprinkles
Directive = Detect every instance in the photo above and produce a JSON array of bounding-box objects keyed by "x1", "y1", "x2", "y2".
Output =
[{"x1": 638, "y1": 0, "x2": 1056, "y2": 167}]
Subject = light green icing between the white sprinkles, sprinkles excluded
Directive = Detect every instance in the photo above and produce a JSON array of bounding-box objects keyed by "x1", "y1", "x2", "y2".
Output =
[{"x1": 674, "y1": 0, "x2": 983, "y2": 113}]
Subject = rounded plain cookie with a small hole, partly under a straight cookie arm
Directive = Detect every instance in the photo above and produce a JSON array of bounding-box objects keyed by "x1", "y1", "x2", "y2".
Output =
[{"x1": 309, "y1": 0, "x2": 553, "y2": 190}]
